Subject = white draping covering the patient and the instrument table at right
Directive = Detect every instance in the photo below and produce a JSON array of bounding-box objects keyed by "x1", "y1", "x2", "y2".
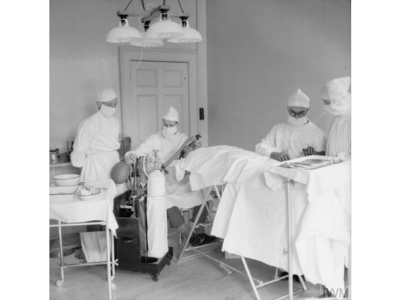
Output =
[{"x1": 179, "y1": 146, "x2": 351, "y2": 288}]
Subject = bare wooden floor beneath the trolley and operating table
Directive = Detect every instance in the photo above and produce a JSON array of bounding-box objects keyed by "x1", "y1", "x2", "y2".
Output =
[{"x1": 49, "y1": 235, "x2": 321, "y2": 300}]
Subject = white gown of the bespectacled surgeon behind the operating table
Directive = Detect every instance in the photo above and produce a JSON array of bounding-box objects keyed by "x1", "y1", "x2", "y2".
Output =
[{"x1": 256, "y1": 121, "x2": 326, "y2": 159}]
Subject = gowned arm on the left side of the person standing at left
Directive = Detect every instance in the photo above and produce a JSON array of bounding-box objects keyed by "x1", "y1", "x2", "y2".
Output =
[{"x1": 71, "y1": 121, "x2": 96, "y2": 168}]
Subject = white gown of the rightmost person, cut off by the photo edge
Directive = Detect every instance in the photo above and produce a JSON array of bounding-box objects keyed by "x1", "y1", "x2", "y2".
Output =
[{"x1": 326, "y1": 110, "x2": 351, "y2": 160}]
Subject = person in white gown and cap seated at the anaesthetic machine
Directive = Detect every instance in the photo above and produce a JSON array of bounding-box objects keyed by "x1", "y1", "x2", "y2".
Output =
[{"x1": 125, "y1": 106, "x2": 215, "y2": 246}]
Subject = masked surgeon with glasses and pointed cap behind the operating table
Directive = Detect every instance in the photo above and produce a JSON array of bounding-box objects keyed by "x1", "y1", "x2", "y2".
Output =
[{"x1": 255, "y1": 89, "x2": 326, "y2": 161}]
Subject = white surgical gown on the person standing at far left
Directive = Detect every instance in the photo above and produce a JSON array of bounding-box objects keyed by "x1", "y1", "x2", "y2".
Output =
[{"x1": 71, "y1": 112, "x2": 120, "y2": 183}]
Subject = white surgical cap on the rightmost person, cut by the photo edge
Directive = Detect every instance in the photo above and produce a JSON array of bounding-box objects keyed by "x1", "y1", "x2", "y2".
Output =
[{"x1": 321, "y1": 76, "x2": 351, "y2": 104}]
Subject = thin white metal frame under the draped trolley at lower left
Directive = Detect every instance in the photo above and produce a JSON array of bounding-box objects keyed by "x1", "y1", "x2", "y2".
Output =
[{"x1": 49, "y1": 220, "x2": 116, "y2": 300}]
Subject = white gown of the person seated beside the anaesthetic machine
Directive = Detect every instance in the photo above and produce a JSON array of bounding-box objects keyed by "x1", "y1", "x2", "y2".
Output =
[{"x1": 125, "y1": 132, "x2": 203, "y2": 209}]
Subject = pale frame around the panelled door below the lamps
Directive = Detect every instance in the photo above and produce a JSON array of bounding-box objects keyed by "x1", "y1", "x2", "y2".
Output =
[{"x1": 119, "y1": 46, "x2": 200, "y2": 139}]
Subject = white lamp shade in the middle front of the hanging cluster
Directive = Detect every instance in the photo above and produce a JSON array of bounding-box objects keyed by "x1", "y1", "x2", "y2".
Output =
[{"x1": 147, "y1": 13, "x2": 183, "y2": 39}]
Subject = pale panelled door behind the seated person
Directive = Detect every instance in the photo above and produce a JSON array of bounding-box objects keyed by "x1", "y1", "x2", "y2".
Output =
[{"x1": 122, "y1": 60, "x2": 190, "y2": 149}]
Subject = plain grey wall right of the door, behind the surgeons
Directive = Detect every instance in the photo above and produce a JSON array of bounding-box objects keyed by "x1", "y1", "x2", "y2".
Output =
[{"x1": 207, "y1": 0, "x2": 351, "y2": 151}]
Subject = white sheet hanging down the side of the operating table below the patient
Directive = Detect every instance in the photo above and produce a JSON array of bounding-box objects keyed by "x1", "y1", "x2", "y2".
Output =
[{"x1": 211, "y1": 180, "x2": 307, "y2": 275}]
